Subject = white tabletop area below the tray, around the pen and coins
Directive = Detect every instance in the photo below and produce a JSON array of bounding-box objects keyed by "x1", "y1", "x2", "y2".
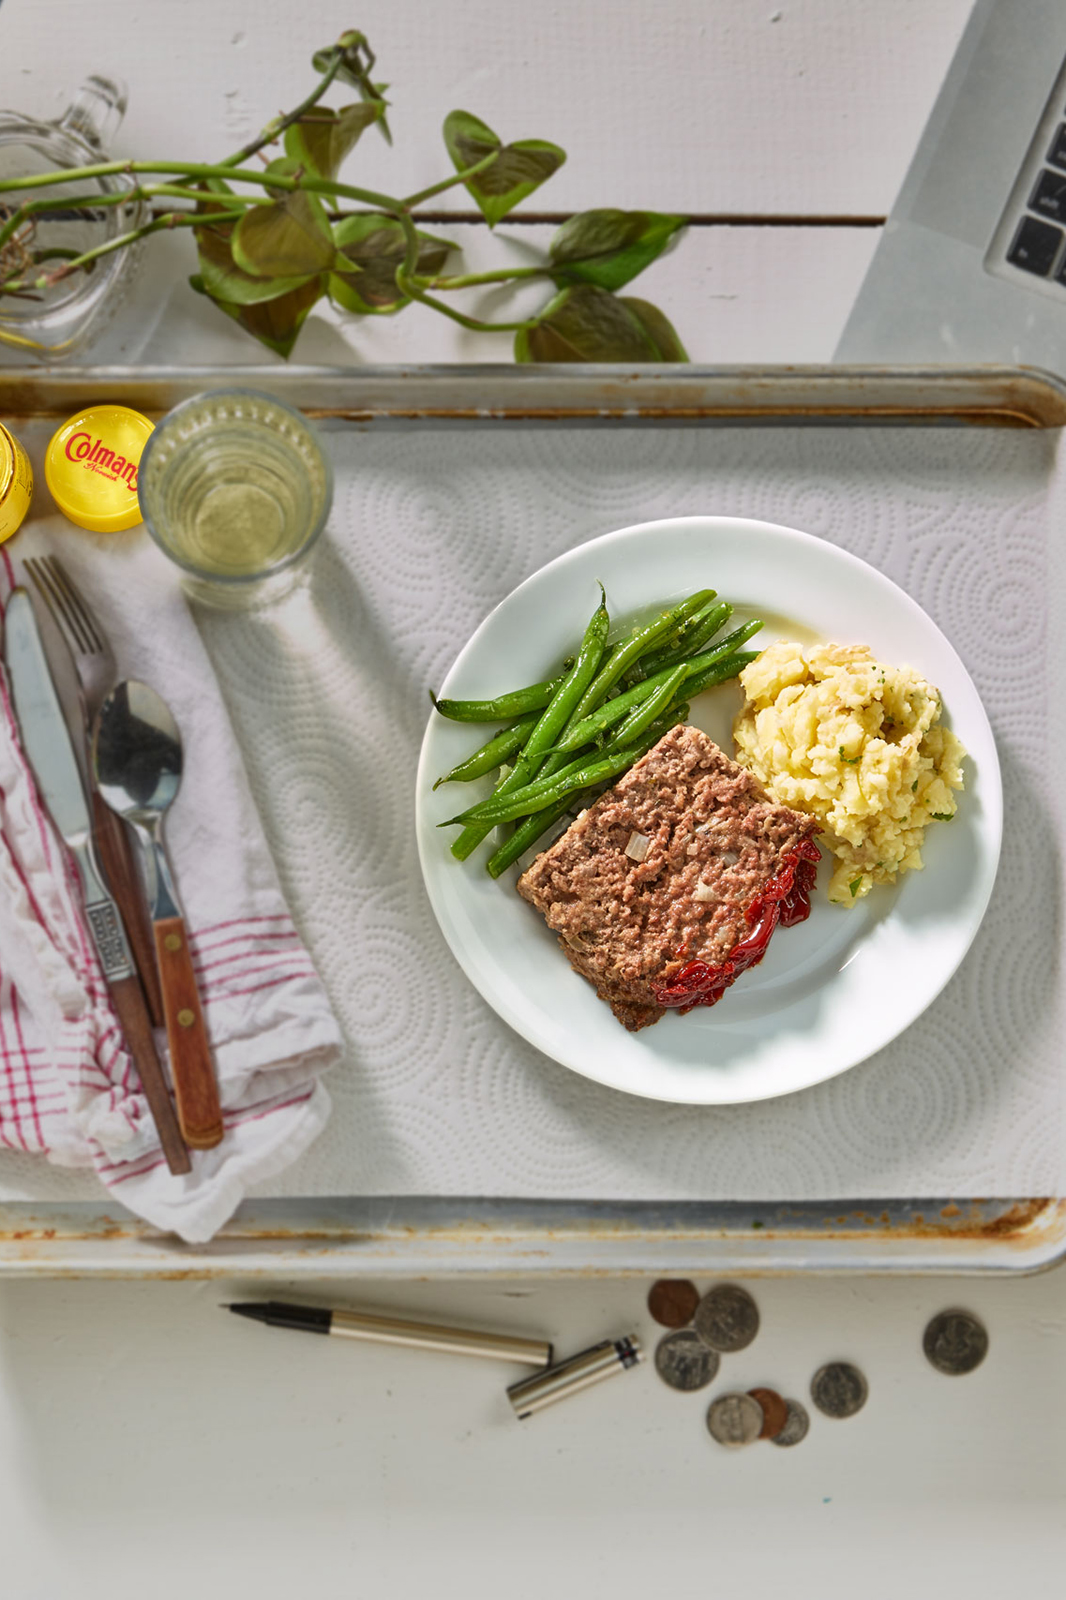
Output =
[{"x1": 0, "y1": 1274, "x2": 1066, "y2": 1600}]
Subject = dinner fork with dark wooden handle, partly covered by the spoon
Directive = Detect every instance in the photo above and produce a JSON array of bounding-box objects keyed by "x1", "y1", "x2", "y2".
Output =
[{"x1": 24, "y1": 555, "x2": 163, "y2": 1027}]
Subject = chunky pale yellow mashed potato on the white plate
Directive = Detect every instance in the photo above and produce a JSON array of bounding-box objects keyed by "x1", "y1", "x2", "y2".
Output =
[{"x1": 733, "y1": 642, "x2": 965, "y2": 906}]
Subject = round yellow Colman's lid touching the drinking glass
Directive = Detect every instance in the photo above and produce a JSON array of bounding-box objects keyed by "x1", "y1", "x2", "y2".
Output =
[{"x1": 45, "y1": 405, "x2": 152, "y2": 533}]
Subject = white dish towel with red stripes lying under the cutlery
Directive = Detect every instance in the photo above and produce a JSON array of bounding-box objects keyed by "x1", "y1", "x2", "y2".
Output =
[{"x1": 0, "y1": 531, "x2": 341, "y2": 1242}]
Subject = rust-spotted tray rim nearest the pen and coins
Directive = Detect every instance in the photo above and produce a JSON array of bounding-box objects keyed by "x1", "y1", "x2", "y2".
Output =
[{"x1": 0, "y1": 1197, "x2": 1066, "y2": 1278}]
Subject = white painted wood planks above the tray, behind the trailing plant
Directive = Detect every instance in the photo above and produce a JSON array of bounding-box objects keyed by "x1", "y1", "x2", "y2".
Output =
[{"x1": 0, "y1": 0, "x2": 970, "y2": 363}]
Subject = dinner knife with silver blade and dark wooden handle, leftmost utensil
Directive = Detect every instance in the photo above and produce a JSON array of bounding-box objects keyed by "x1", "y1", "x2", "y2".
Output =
[{"x1": 5, "y1": 589, "x2": 192, "y2": 1174}]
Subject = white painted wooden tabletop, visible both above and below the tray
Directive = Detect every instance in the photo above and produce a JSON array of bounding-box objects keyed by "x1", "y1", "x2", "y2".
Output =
[{"x1": 0, "y1": 0, "x2": 1066, "y2": 1600}]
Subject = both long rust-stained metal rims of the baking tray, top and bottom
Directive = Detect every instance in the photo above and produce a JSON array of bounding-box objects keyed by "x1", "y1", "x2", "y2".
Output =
[{"x1": 0, "y1": 366, "x2": 1066, "y2": 1277}]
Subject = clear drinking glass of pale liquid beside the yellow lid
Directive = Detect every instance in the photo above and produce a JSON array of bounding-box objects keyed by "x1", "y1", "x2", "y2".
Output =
[{"x1": 138, "y1": 389, "x2": 333, "y2": 610}]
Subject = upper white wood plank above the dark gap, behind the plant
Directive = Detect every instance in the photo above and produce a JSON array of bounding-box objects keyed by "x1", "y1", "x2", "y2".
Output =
[{"x1": 0, "y1": 0, "x2": 970, "y2": 216}]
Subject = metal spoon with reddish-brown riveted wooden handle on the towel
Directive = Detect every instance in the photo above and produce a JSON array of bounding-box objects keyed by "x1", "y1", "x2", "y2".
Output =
[{"x1": 93, "y1": 678, "x2": 222, "y2": 1150}]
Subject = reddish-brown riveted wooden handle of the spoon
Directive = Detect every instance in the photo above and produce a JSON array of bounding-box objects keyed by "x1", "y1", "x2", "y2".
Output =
[{"x1": 152, "y1": 917, "x2": 222, "y2": 1150}]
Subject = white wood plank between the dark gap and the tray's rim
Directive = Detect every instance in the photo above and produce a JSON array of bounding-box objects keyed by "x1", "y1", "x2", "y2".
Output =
[{"x1": 76, "y1": 222, "x2": 877, "y2": 366}]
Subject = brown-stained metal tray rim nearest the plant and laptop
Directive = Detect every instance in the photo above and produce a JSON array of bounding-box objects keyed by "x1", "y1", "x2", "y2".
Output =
[{"x1": 0, "y1": 365, "x2": 1066, "y2": 427}]
